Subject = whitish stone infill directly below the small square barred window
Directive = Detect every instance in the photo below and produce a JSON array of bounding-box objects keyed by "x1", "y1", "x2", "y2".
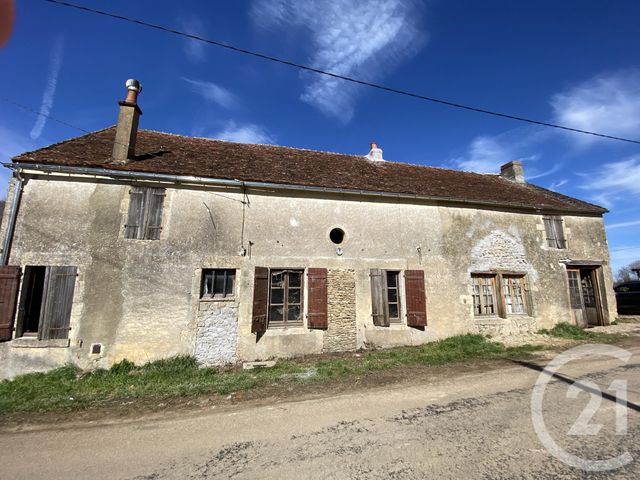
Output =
[{"x1": 194, "y1": 302, "x2": 238, "y2": 366}]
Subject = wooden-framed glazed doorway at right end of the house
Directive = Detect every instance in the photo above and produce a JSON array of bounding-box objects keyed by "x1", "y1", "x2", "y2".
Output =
[{"x1": 567, "y1": 266, "x2": 604, "y2": 328}]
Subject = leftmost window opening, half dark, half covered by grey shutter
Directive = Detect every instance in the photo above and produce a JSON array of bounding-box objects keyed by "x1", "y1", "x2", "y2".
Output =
[{"x1": 16, "y1": 267, "x2": 77, "y2": 340}]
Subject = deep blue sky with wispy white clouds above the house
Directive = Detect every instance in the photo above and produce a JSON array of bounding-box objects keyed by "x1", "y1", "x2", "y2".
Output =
[{"x1": 0, "y1": 0, "x2": 640, "y2": 269}]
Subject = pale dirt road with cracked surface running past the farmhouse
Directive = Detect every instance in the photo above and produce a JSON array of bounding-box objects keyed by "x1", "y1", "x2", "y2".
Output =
[{"x1": 0, "y1": 346, "x2": 640, "y2": 480}]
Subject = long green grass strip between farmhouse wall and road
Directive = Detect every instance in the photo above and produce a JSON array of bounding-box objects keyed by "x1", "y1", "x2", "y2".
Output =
[{"x1": 0, "y1": 334, "x2": 540, "y2": 415}]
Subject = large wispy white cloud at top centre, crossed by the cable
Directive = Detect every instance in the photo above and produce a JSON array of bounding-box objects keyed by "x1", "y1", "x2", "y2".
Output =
[{"x1": 252, "y1": 0, "x2": 426, "y2": 123}]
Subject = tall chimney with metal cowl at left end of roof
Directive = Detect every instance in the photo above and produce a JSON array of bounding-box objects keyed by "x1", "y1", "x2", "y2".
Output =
[{"x1": 112, "y1": 78, "x2": 142, "y2": 165}]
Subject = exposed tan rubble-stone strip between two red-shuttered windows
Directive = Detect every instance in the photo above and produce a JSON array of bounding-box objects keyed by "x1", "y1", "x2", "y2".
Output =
[{"x1": 323, "y1": 269, "x2": 357, "y2": 352}]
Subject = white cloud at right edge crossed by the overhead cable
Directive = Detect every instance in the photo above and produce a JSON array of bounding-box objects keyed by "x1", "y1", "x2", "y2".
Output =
[{"x1": 551, "y1": 70, "x2": 640, "y2": 145}]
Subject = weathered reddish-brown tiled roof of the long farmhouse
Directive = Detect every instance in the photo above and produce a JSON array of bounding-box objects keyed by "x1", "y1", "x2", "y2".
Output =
[{"x1": 13, "y1": 127, "x2": 606, "y2": 215}]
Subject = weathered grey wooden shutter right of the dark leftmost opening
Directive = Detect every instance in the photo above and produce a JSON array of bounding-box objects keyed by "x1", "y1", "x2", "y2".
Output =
[{"x1": 38, "y1": 267, "x2": 78, "y2": 340}]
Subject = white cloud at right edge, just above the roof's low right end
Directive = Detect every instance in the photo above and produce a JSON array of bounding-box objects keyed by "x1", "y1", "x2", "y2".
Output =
[{"x1": 580, "y1": 155, "x2": 640, "y2": 208}]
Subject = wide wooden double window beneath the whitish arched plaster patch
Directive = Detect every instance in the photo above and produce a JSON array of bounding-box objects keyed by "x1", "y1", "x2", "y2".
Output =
[{"x1": 471, "y1": 273, "x2": 532, "y2": 318}]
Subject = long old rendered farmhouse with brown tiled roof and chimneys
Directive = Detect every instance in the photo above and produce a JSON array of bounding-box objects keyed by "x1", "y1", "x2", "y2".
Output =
[{"x1": 0, "y1": 81, "x2": 616, "y2": 377}]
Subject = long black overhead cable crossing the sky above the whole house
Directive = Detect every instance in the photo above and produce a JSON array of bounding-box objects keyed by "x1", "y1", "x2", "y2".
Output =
[{"x1": 44, "y1": 0, "x2": 640, "y2": 144}]
